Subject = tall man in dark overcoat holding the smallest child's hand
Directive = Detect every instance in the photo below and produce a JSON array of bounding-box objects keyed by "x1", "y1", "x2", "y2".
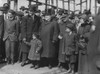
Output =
[{"x1": 21, "y1": 5, "x2": 41, "y2": 66}]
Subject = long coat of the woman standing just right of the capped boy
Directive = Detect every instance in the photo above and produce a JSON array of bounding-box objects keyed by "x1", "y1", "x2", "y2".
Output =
[{"x1": 77, "y1": 25, "x2": 91, "y2": 74}]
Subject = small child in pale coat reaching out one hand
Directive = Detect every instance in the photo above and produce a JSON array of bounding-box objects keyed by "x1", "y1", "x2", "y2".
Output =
[{"x1": 24, "y1": 33, "x2": 42, "y2": 69}]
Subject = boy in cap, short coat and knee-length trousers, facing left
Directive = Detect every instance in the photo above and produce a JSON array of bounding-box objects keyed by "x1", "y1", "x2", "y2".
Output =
[{"x1": 62, "y1": 23, "x2": 76, "y2": 73}]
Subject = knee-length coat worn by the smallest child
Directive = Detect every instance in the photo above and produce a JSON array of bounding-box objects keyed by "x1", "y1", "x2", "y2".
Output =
[{"x1": 28, "y1": 39, "x2": 42, "y2": 60}]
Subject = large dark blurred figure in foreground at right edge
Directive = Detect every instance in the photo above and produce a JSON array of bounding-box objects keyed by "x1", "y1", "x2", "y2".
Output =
[{"x1": 85, "y1": 9, "x2": 100, "y2": 74}]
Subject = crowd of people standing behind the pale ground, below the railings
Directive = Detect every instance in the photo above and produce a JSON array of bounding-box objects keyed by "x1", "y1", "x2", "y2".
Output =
[{"x1": 0, "y1": 3, "x2": 99, "y2": 74}]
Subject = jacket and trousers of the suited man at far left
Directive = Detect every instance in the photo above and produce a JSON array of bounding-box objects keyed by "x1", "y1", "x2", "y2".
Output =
[{"x1": 3, "y1": 19, "x2": 19, "y2": 61}]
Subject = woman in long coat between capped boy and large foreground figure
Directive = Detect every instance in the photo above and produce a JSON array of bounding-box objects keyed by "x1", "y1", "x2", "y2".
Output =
[{"x1": 77, "y1": 22, "x2": 91, "y2": 74}]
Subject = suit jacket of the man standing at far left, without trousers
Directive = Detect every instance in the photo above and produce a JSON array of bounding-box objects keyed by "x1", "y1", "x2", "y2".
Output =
[{"x1": 3, "y1": 19, "x2": 19, "y2": 41}]
